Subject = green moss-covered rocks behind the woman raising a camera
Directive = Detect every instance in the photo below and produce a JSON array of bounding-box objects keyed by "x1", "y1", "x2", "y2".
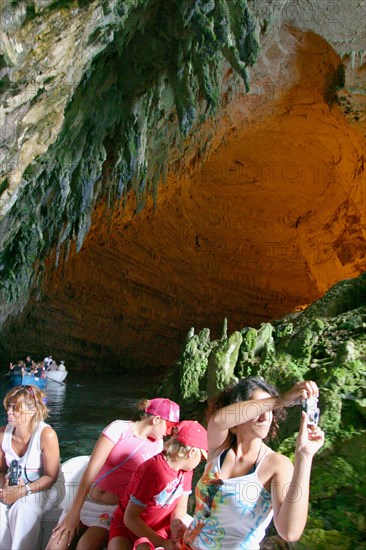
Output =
[{"x1": 168, "y1": 273, "x2": 366, "y2": 549}]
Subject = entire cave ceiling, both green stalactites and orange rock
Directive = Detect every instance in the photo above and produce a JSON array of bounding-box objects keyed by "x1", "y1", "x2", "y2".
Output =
[{"x1": 0, "y1": 0, "x2": 366, "y2": 367}]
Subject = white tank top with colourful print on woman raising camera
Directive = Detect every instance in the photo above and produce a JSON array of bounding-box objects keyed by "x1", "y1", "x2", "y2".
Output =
[{"x1": 184, "y1": 451, "x2": 273, "y2": 550}]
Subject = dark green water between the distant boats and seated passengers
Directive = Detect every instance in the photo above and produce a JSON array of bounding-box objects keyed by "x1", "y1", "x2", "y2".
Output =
[{"x1": 0, "y1": 372, "x2": 163, "y2": 462}]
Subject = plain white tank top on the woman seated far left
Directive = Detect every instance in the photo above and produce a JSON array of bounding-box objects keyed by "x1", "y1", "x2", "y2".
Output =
[{"x1": 2, "y1": 422, "x2": 48, "y2": 483}]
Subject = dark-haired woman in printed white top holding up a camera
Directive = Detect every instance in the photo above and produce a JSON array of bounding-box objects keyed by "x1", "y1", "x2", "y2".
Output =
[{"x1": 182, "y1": 378, "x2": 324, "y2": 550}]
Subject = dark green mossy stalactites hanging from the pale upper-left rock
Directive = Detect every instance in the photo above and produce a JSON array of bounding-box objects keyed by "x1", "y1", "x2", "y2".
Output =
[{"x1": 0, "y1": 0, "x2": 259, "y2": 310}]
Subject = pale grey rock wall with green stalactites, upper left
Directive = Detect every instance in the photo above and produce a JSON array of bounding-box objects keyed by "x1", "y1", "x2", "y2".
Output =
[{"x1": 0, "y1": 0, "x2": 259, "y2": 314}]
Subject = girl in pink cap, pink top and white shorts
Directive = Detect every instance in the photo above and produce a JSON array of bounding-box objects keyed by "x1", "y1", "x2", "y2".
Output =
[{"x1": 46, "y1": 397, "x2": 179, "y2": 550}]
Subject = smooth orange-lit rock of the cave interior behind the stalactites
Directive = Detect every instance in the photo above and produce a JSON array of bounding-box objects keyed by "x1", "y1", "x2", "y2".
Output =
[{"x1": 10, "y1": 27, "x2": 366, "y2": 366}]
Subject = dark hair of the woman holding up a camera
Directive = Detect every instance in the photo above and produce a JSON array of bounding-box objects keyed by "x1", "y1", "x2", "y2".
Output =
[{"x1": 207, "y1": 376, "x2": 286, "y2": 447}]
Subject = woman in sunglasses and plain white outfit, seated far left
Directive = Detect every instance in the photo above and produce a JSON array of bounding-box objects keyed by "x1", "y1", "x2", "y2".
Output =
[{"x1": 0, "y1": 386, "x2": 60, "y2": 550}]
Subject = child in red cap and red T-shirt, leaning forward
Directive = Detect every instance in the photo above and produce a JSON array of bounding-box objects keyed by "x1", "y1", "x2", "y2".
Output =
[{"x1": 108, "y1": 420, "x2": 208, "y2": 550}]
